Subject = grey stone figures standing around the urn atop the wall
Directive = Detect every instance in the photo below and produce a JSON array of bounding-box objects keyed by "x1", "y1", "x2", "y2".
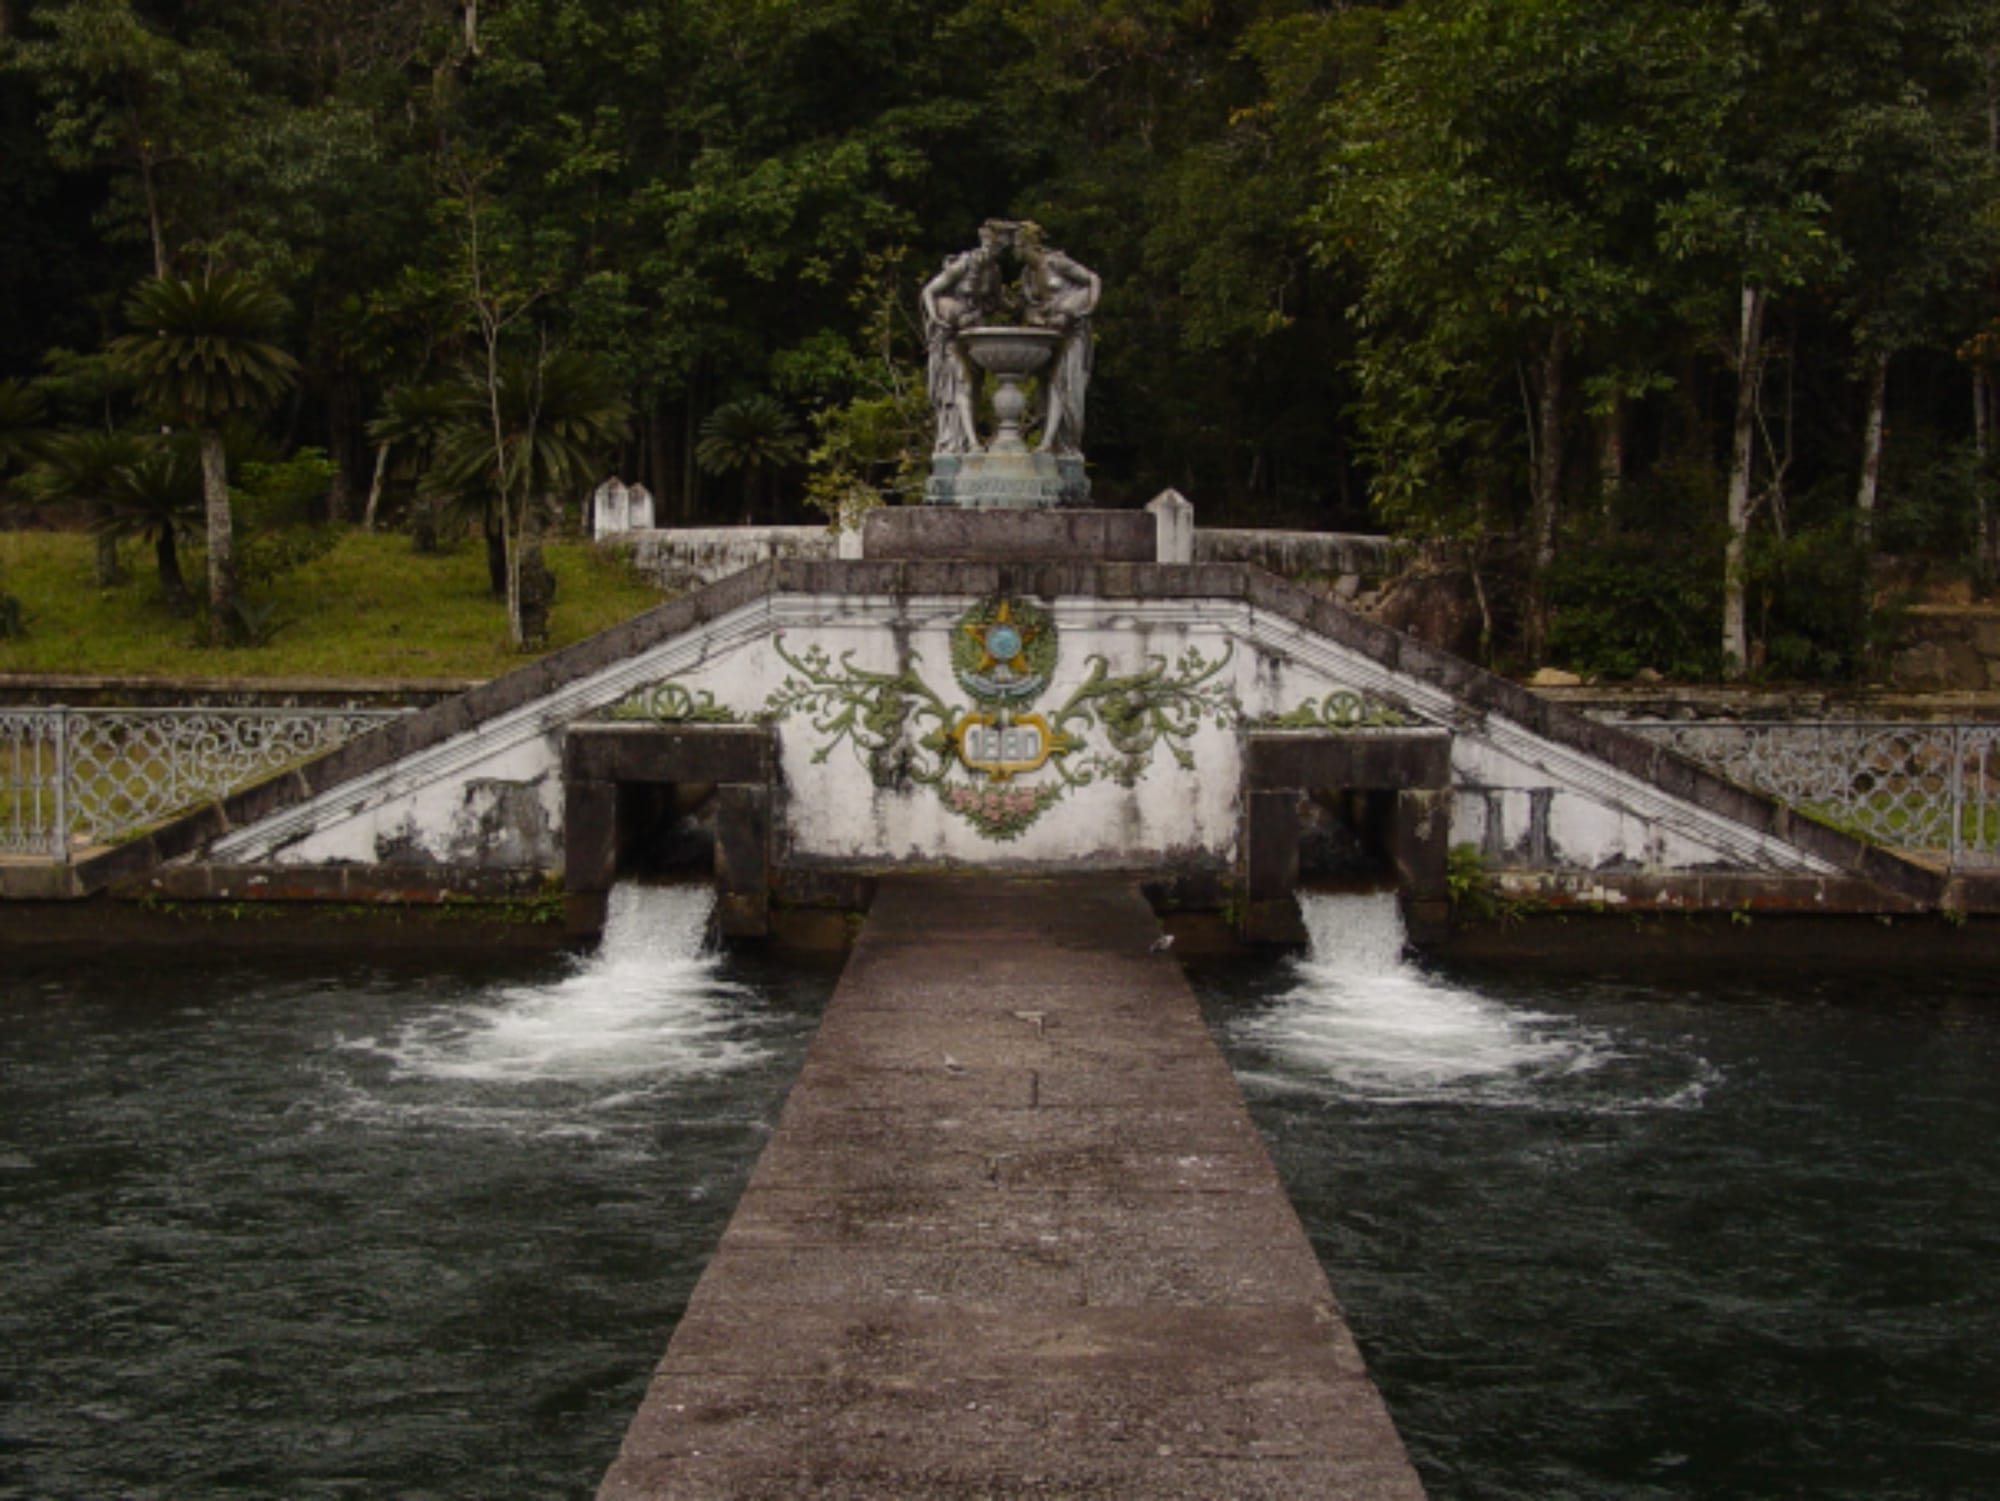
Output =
[{"x1": 922, "y1": 218, "x2": 1100, "y2": 458}]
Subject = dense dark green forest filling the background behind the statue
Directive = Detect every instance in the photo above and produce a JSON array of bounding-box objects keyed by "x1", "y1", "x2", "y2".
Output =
[{"x1": 0, "y1": 0, "x2": 2000, "y2": 676}]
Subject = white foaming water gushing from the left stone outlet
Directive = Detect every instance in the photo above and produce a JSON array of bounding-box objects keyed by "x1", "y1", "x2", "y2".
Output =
[{"x1": 344, "y1": 885, "x2": 764, "y2": 1107}]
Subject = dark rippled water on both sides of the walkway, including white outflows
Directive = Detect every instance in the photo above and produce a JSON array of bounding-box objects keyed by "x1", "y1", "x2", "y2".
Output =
[{"x1": 0, "y1": 889, "x2": 2000, "y2": 1501}]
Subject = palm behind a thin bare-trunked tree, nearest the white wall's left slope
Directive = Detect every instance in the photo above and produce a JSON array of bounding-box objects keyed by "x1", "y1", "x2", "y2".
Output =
[{"x1": 426, "y1": 350, "x2": 632, "y2": 646}]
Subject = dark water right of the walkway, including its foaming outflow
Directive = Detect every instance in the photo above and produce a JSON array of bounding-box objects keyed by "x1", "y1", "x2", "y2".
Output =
[{"x1": 1196, "y1": 897, "x2": 2000, "y2": 1501}]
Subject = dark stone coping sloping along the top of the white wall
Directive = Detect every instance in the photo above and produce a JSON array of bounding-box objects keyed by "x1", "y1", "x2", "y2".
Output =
[{"x1": 76, "y1": 558, "x2": 1946, "y2": 907}]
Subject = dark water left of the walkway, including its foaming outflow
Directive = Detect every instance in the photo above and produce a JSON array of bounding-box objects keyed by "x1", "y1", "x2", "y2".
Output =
[{"x1": 0, "y1": 889, "x2": 832, "y2": 1501}]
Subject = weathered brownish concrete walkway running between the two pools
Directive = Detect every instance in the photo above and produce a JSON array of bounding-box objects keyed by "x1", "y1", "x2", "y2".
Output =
[{"x1": 600, "y1": 877, "x2": 1422, "y2": 1501}]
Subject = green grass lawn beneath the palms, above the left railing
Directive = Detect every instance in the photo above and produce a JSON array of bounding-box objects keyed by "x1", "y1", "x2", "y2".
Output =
[{"x1": 0, "y1": 530, "x2": 662, "y2": 678}]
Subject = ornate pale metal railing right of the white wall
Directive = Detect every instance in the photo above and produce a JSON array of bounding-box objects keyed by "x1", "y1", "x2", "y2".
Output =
[{"x1": 1620, "y1": 720, "x2": 2000, "y2": 869}]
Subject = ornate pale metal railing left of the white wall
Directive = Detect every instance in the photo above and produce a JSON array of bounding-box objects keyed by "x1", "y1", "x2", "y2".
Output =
[{"x1": 0, "y1": 708, "x2": 408, "y2": 861}]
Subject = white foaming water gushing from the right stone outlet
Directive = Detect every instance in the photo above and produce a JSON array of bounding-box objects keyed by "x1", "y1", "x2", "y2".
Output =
[{"x1": 1236, "y1": 891, "x2": 1616, "y2": 1105}]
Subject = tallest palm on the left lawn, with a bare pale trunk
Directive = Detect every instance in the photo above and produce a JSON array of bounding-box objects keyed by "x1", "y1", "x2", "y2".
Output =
[{"x1": 110, "y1": 272, "x2": 298, "y2": 646}]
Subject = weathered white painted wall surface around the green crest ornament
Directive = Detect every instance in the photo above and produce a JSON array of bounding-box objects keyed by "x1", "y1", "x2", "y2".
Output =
[{"x1": 199, "y1": 594, "x2": 1828, "y2": 873}]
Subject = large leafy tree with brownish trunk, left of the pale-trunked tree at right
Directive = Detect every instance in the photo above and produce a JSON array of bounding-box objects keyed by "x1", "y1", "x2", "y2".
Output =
[{"x1": 1316, "y1": 0, "x2": 1730, "y2": 660}]
